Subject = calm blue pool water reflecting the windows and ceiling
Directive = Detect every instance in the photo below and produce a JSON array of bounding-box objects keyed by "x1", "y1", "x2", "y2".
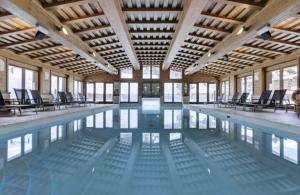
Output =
[{"x1": 0, "y1": 105, "x2": 300, "y2": 195}]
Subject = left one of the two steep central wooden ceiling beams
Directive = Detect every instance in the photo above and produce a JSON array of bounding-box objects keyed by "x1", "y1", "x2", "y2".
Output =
[{"x1": 99, "y1": 0, "x2": 140, "y2": 70}]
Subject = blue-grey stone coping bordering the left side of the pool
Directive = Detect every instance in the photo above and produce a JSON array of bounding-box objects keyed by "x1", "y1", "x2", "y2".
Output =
[{"x1": 0, "y1": 104, "x2": 119, "y2": 135}]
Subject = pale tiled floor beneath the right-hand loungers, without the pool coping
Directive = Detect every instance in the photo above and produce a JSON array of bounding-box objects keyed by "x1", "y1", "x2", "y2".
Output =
[{"x1": 189, "y1": 104, "x2": 300, "y2": 127}]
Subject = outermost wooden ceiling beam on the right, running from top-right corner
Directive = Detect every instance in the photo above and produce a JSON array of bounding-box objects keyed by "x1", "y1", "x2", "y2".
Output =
[{"x1": 185, "y1": 0, "x2": 300, "y2": 74}]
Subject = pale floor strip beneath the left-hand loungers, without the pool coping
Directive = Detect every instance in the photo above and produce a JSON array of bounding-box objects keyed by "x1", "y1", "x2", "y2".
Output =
[{"x1": 0, "y1": 104, "x2": 113, "y2": 132}]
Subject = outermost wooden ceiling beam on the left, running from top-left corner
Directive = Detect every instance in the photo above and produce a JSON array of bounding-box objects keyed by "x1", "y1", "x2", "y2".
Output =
[{"x1": 0, "y1": 0, "x2": 117, "y2": 74}]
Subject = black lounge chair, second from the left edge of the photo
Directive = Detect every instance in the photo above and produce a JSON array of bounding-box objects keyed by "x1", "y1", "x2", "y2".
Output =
[{"x1": 14, "y1": 89, "x2": 38, "y2": 114}]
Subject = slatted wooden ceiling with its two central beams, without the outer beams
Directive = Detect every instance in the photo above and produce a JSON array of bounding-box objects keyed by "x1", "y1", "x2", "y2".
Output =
[{"x1": 0, "y1": 0, "x2": 300, "y2": 76}]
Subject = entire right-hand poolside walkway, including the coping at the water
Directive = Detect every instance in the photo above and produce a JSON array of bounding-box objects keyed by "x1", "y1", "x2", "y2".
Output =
[{"x1": 185, "y1": 104, "x2": 300, "y2": 134}]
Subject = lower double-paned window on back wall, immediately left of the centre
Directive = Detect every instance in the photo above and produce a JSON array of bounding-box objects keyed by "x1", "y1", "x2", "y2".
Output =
[{"x1": 120, "y1": 82, "x2": 138, "y2": 102}]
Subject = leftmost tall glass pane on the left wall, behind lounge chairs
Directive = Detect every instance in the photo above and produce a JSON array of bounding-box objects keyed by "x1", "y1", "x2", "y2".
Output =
[{"x1": 8, "y1": 66, "x2": 22, "y2": 99}]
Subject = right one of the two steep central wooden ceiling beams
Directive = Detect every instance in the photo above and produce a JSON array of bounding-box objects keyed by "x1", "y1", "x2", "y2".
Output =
[{"x1": 163, "y1": 0, "x2": 208, "y2": 70}]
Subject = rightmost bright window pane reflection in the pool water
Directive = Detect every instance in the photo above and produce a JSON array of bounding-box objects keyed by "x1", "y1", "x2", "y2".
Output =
[{"x1": 283, "y1": 138, "x2": 298, "y2": 164}]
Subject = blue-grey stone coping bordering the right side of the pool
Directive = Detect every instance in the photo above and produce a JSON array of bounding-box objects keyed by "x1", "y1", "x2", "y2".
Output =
[{"x1": 183, "y1": 104, "x2": 300, "y2": 135}]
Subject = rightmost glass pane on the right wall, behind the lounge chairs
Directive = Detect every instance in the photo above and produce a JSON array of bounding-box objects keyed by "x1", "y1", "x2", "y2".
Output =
[{"x1": 283, "y1": 66, "x2": 298, "y2": 101}]
